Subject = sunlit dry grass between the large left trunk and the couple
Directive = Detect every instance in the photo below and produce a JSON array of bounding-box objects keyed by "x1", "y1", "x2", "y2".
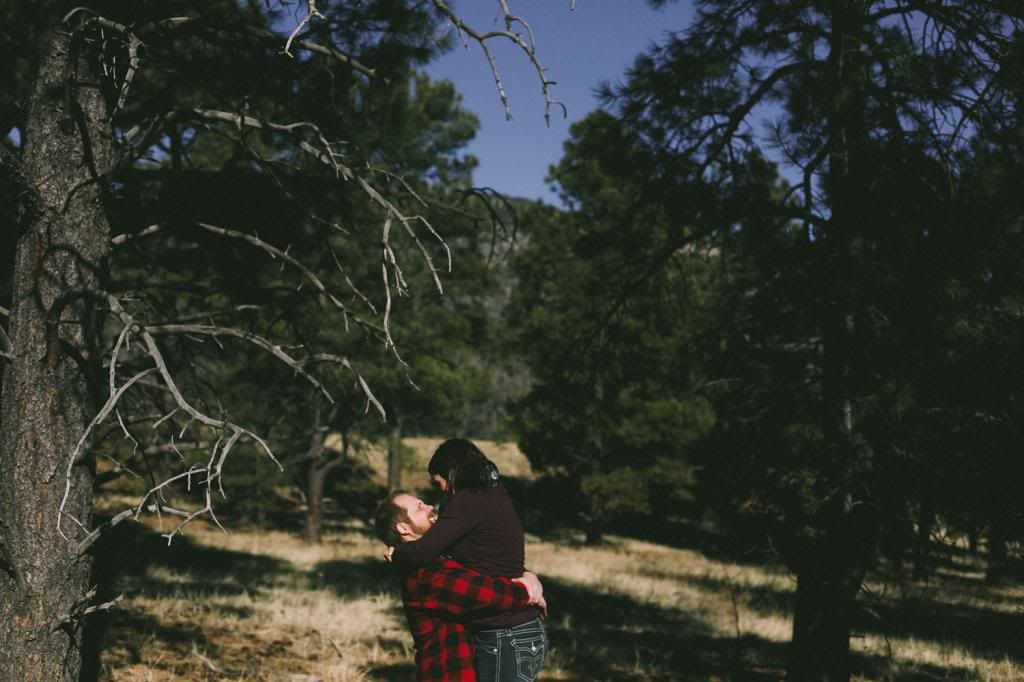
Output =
[{"x1": 102, "y1": 518, "x2": 412, "y2": 682}]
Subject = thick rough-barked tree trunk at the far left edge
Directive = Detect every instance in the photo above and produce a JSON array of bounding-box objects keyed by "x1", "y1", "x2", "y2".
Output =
[{"x1": 0, "y1": 21, "x2": 113, "y2": 682}]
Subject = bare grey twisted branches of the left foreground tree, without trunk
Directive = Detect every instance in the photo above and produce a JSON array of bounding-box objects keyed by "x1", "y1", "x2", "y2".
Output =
[{"x1": 41, "y1": 0, "x2": 574, "y2": 561}]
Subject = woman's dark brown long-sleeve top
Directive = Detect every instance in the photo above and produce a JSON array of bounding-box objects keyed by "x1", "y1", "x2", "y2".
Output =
[{"x1": 391, "y1": 486, "x2": 540, "y2": 629}]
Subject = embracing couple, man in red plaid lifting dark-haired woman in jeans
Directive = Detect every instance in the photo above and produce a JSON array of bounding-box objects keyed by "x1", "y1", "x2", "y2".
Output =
[{"x1": 376, "y1": 438, "x2": 548, "y2": 682}]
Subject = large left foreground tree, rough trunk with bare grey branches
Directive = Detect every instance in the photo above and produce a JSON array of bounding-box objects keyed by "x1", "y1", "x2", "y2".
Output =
[{"x1": 0, "y1": 0, "x2": 569, "y2": 682}]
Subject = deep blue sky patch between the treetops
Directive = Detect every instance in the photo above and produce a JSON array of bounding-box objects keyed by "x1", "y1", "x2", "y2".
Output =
[{"x1": 426, "y1": 0, "x2": 692, "y2": 205}]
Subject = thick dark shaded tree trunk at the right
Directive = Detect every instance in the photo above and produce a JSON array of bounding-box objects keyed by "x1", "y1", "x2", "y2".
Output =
[{"x1": 786, "y1": 0, "x2": 878, "y2": 682}]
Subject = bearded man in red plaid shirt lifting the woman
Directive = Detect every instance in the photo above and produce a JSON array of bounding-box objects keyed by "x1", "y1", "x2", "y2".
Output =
[{"x1": 376, "y1": 491, "x2": 546, "y2": 682}]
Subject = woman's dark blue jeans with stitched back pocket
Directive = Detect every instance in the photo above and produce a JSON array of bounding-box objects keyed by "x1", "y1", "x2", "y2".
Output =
[{"x1": 473, "y1": 619, "x2": 548, "y2": 682}]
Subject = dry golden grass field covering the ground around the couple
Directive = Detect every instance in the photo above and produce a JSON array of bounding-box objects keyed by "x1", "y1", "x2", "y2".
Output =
[{"x1": 90, "y1": 439, "x2": 1024, "y2": 682}]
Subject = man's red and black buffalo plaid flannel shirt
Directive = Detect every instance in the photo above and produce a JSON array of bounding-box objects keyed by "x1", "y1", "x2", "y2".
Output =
[{"x1": 401, "y1": 559, "x2": 529, "y2": 682}]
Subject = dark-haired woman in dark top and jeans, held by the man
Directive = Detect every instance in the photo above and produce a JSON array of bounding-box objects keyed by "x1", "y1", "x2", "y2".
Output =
[{"x1": 391, "y1": 438, "x2": 548, "y2": 682}]
